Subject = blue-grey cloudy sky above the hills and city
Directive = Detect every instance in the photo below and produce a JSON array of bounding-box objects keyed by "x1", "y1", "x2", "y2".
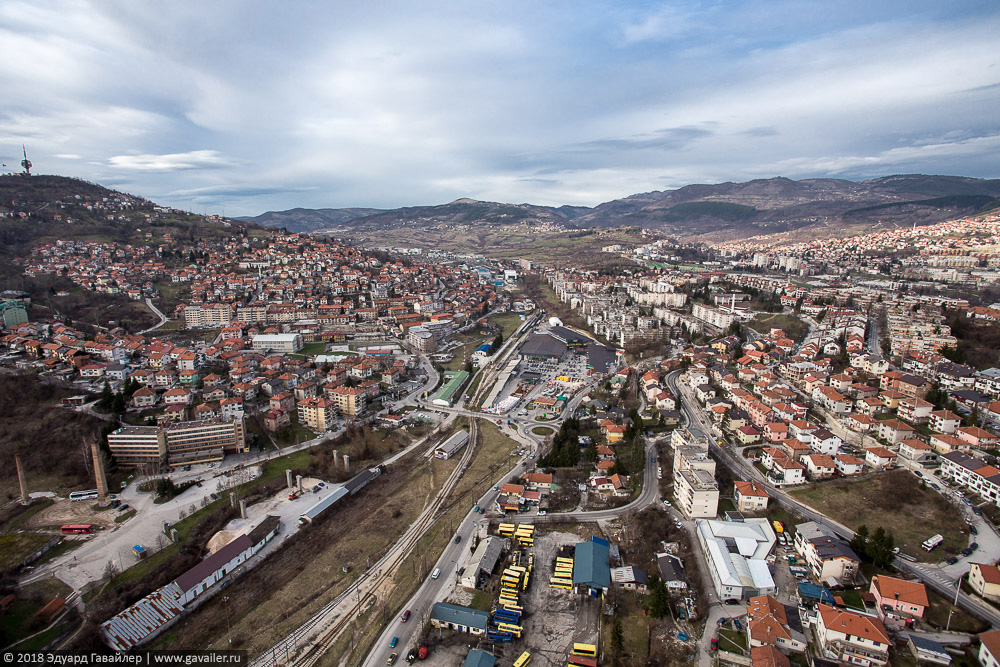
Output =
[{"x1": 0, "y1": 0, "x2": 1000, "y2": 215}]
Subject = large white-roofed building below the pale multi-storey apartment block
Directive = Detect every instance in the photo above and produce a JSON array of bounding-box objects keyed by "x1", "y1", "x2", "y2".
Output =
[{"x1": 695, "y1": 519, "x2": 777, "y2": 600}]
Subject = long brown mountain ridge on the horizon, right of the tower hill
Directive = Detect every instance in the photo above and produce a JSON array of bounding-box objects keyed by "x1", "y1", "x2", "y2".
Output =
[{"x1": 244, "y1": 174, "x2": 1000, "y2": 237}]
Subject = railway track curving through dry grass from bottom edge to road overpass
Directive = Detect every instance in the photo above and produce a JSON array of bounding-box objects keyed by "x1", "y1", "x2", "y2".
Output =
[{"x1": 260, "y1": 418, "x2": 477, "y2": 667}]
